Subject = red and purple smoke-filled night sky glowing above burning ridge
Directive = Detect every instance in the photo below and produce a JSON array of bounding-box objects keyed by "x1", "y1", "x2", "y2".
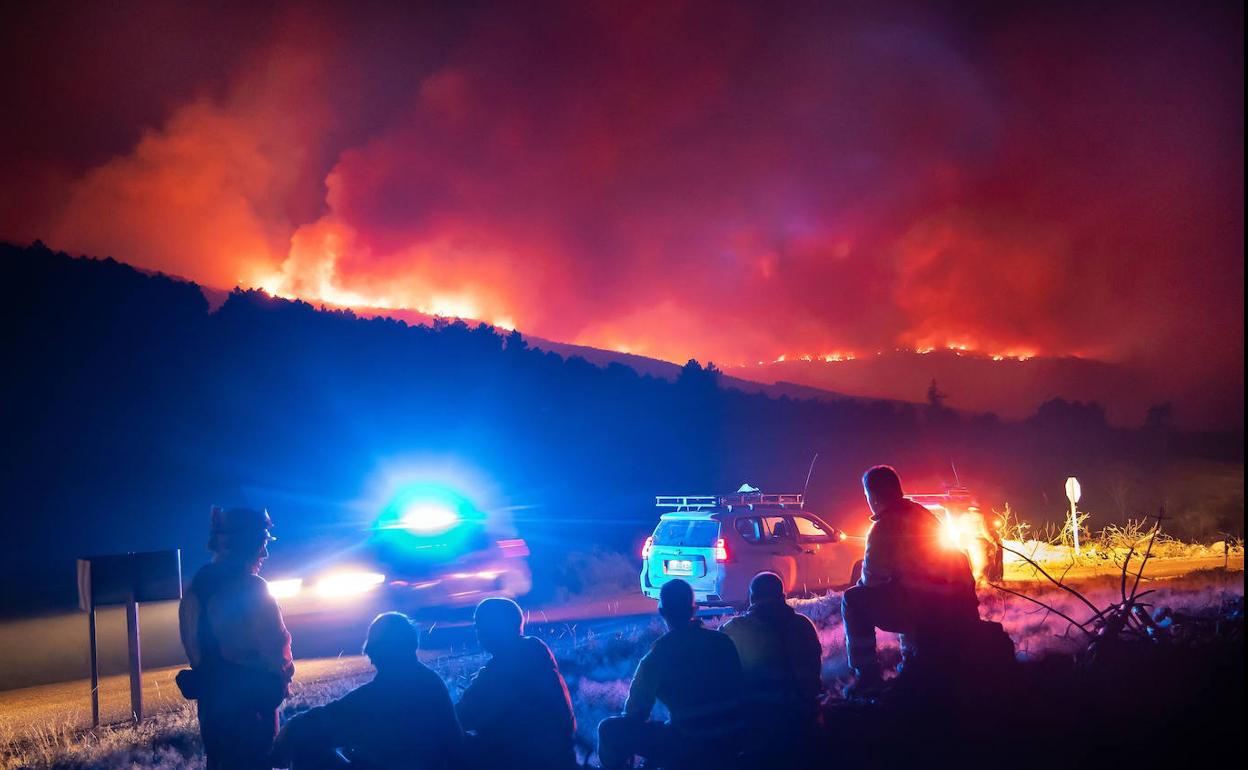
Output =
[{"x1": 0, "y1": 1, "x2": 1244, "y2": 423}]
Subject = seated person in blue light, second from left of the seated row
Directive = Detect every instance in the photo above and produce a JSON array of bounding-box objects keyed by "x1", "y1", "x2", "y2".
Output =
[{"x1": 456, "y1": 598, "x2": 577, "y2": 770}]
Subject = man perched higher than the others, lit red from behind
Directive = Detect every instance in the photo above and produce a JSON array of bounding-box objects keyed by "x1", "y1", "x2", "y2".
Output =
[{"x1": 841, "y1": 465, "x2": 980, "y2": 694}]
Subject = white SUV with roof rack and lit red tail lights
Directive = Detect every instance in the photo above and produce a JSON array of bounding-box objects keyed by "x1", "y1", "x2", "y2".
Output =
[{"x1": 641, "y1": 492, "x2": 865, "y2": 607}]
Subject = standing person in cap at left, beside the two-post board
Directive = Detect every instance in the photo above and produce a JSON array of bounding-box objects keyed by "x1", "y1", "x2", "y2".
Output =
[{"x1": 177, "y1": 508, "x2": 295, "y2": 770}]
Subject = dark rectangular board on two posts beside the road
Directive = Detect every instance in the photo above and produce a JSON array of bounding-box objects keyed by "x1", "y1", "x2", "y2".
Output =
[{"x1": 77, "y1": 549, "x2": 182, "y2": 726}]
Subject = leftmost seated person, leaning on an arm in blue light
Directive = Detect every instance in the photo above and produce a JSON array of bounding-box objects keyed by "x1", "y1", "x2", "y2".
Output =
[{"x1": 273, "y1": 613, "x2": 463, "y2": 770}]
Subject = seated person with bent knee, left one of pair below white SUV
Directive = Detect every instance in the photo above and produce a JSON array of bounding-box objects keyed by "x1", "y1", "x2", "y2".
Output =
[{"x1": 598, "y1": 579, "x2": 741, "y2": 769}]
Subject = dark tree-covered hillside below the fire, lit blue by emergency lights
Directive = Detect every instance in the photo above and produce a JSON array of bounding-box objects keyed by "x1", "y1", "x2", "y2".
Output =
[{"x1": 0, "y1": 243, "x2": 1243, "y2": 610}]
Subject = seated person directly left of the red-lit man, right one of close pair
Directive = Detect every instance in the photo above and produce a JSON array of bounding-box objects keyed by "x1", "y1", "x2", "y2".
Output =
[{"x1": 724, "y1": 572, "x2": 824, "y2": 740}]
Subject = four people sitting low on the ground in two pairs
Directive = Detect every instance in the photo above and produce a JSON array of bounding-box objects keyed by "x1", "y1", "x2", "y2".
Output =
[{"x1": 272, "y1": 573, "x2": 822, "y2": 770}]
